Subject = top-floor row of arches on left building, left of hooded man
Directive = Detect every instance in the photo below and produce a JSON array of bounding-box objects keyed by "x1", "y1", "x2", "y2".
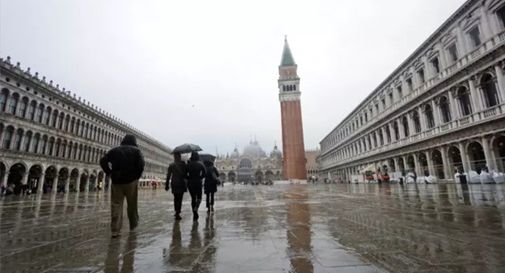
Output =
[{"x1": 0, "y1": 88, "x2": 121, "y2": 145}]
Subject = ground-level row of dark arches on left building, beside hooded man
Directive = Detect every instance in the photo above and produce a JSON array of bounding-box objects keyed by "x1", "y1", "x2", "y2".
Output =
[{"x1": 0, "y1": 161, "x2": 108, "y2": 194}]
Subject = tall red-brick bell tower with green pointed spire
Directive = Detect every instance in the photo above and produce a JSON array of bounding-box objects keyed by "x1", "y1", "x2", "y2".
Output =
[{"x1": 278, "y1": 38, "x2": 307, "y2": 179}]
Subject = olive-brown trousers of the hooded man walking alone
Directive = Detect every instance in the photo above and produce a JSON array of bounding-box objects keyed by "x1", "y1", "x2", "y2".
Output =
[{"x1": 110, "y1": 180, "x2": 139, "y2": 233}]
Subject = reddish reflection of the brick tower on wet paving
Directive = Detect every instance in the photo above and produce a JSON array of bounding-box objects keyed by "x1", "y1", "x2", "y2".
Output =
[{"x1": 285, "y1": 185, "x2": 314, "y2": 273}]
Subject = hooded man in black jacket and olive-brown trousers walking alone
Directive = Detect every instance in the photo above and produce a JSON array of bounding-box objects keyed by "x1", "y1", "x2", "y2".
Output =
[{"x1": 100, "y1": 135, "x2": 145, "y2": 237}]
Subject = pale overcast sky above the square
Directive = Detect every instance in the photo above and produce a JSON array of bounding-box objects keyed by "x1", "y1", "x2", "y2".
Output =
[{"x1": 0, "y1": 0, "x2": 465, "y2": 153}]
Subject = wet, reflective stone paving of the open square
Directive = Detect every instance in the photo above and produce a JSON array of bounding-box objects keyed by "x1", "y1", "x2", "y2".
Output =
[{"x1": 0, "y1": 184, "x2": 505, "y2": 273}]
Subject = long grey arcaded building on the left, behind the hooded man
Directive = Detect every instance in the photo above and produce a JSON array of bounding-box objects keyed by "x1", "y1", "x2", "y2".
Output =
[{"x1": 0, "y1": 57, "x2": 172, "y2": 193}]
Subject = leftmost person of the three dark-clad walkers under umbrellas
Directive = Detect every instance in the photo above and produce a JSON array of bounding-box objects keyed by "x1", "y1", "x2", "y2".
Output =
[{"x1": 165, "y1": 153, "x2": 188, "y2": 220}]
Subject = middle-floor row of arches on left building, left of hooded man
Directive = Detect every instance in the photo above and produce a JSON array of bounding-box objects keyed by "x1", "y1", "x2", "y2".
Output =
[{"x1": 0, "y1": 123, "x2": 106, "y2": 163}]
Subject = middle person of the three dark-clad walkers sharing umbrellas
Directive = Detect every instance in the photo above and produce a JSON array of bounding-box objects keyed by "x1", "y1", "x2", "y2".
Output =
[{"x1": 188, "y1": 152, "x2": 206, "y2": 221}]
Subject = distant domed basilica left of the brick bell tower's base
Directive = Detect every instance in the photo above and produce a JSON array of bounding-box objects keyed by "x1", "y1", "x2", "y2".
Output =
[{"x1": 216, "y1": 140, "x2": 282, "y2": 183}]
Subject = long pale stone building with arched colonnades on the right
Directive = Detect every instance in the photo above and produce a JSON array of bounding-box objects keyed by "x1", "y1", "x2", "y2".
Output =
[{"x1": 318, "y1": 0, "x2": 505, "y2": 181}]
